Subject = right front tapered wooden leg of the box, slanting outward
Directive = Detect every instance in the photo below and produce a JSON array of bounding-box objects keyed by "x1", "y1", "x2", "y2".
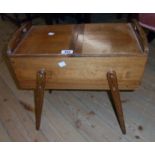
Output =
[{"x1": 107, "y1": 71, "x2": 126, "y2": 134}]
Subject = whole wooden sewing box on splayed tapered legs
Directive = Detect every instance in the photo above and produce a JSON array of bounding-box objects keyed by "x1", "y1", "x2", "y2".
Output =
[{"x1": 6, "y1": 21, "x2": 148, "y2": 134}]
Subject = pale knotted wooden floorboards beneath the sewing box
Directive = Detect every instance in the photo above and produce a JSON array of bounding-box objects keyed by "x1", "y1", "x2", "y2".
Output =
[{"x1": 0, "y1": 47, "x2": 155, "y2": 142}]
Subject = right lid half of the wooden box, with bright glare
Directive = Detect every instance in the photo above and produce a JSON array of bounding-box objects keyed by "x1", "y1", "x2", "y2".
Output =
[{"x1": 82, "y1": 24, "x2": 141, "y2": 56}]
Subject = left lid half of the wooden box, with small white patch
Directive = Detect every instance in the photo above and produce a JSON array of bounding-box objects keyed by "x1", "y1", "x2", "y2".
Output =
[{"x1": 15, "y1": 25, "x2": 74, "y2": 55}]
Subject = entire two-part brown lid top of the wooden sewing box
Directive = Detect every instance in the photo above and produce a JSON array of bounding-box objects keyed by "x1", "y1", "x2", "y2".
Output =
[{"x1": 11, "y1": 23, "x2": 146, "y2": 56}]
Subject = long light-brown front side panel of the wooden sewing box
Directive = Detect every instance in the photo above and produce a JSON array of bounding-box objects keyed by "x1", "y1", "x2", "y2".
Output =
[{"x1": 11, "y1": 56, "x2": 147, "y2": 90}]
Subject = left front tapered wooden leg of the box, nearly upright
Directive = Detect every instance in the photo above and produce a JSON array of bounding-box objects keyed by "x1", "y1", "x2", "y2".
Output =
[{"x1": 34, "y1": 69, "x2": 46, "y2": 130}]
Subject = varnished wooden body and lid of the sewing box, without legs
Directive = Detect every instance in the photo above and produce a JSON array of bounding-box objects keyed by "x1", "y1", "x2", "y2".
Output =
[{"x1": 6, "y1": 23, "x2": 147, "y2": 90}]
